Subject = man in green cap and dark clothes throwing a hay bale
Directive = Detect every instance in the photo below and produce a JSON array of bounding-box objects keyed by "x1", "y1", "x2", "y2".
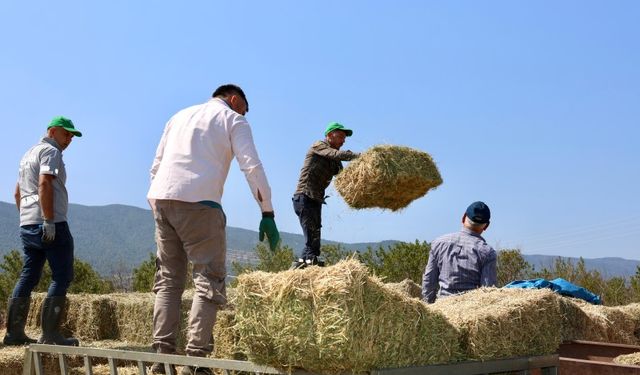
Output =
[{"x1": 292, "y1": 122, "x2": 359, "y2": 268}]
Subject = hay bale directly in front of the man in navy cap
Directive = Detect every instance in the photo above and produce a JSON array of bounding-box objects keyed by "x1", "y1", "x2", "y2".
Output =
[{"x1": 432, "y1": 288, "x2": 561, "y2": 360}]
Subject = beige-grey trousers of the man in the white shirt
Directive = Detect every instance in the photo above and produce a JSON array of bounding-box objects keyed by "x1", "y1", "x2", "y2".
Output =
[{"x1": 149, "y1": 200, "x2": 227, "y2": 357}]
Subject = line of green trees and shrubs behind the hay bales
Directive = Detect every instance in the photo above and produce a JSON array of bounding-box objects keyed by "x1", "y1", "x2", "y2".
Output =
[{"x1": 0, "y1": 244, "x2": 640, "y2": 311}]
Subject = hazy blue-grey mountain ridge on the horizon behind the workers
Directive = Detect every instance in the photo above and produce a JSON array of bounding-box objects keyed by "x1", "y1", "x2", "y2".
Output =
[{"x1": 0, "y1": 202, "x2": 640, "y2": 277}]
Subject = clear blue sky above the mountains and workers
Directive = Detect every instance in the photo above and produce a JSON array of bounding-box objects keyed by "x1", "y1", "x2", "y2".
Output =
[{"x1": 0, "y1": 0, "x2": 640, "y2": 259}]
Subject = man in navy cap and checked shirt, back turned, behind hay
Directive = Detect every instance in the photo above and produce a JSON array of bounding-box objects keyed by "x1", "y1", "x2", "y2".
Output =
[{"x1": 422, "y1": 201, "x2": 497, "y2": 303}]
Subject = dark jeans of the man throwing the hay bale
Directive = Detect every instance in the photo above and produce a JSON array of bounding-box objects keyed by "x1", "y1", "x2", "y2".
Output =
[{"x1": 292, "y1": 194, "x2": 322, "y2": 259}]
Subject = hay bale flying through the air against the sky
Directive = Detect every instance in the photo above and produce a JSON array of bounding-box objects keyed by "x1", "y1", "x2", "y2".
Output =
[{"x1": 334, "y1": 145, "x2": 442, "y2": 211}]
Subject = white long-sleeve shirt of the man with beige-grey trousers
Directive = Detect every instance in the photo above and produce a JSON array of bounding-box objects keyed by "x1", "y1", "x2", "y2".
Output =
[{"x1": 147, "y1": 98, "x2": 273, "y2": 212}]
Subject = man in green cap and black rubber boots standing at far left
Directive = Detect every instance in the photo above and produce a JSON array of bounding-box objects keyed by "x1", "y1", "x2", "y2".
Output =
[{"x1": 3, "y1": 116, "x2": 82, "y2": 346}]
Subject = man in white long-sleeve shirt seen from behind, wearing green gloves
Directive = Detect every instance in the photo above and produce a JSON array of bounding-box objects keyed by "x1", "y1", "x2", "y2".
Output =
[{"x1": 147, "y1": 85, "x2": 280, "y2": 374}]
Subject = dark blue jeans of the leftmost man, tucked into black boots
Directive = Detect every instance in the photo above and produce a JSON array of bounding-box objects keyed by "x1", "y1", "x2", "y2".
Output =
[{"x1": 13, "y1": 222, "x2": 73, "y2": 298}]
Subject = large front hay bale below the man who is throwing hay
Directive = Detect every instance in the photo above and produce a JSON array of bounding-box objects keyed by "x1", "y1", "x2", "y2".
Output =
[{"x1": 236, "y1": 259, "x2": 459, "y2": 373}]
